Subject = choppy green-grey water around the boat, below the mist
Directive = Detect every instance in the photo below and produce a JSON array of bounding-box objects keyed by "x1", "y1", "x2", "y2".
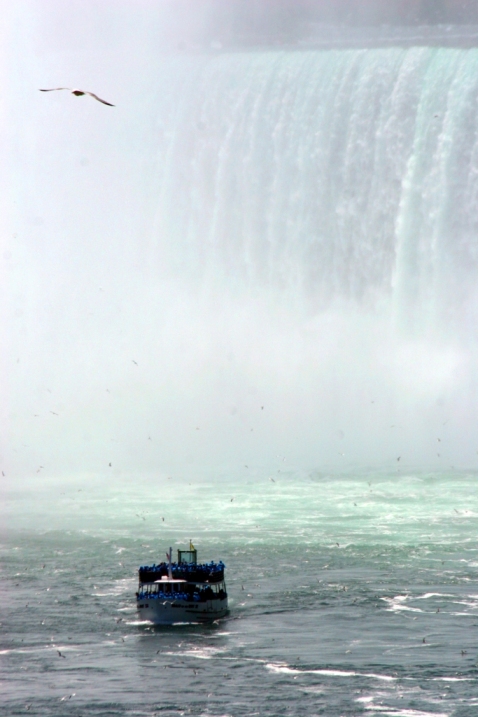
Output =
[{"x1": 1, "y1": 468, "x2": 478, "y2": 717}]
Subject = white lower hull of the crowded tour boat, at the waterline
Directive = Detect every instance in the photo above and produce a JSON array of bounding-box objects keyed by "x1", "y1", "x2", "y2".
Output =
[{"x1": 137, "y1": 597, "x2": 228, "y2": 625}]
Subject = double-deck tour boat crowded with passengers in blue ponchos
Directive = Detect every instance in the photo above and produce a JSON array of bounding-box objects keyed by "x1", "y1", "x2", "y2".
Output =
[{"x1": 136, "y1": 543, "x2": 228, "y2": 625}]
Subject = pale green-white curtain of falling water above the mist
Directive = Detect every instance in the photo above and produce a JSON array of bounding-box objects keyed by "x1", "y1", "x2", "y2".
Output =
[{"x1": 152, "y1": 48, "x2": 478, "y2": 333}]
